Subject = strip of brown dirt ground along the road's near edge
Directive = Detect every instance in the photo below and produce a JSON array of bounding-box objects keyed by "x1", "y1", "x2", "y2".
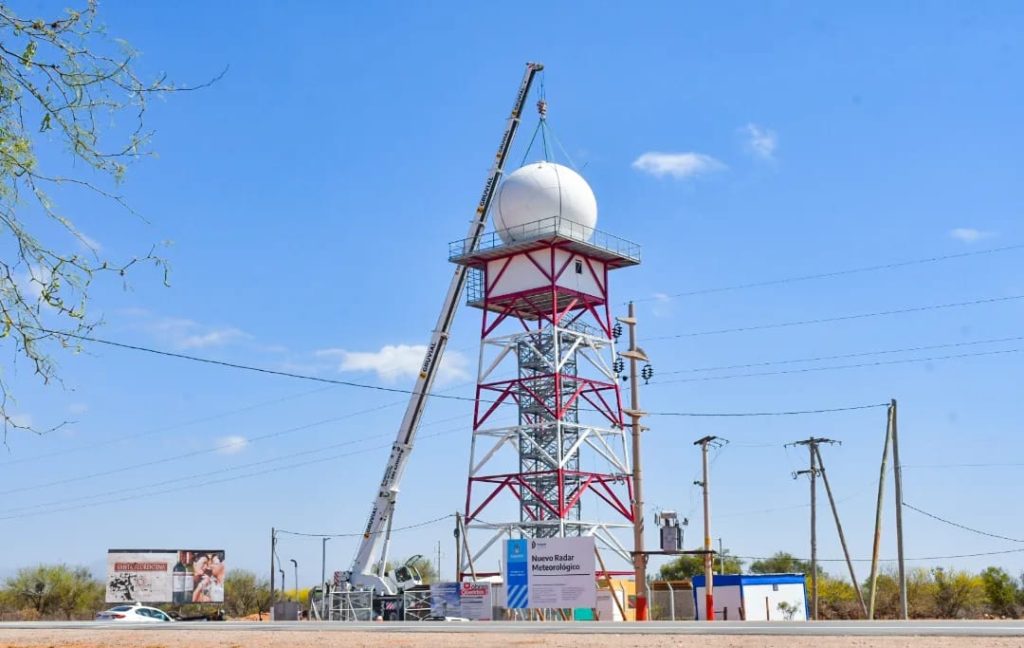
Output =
[{"x1": 0, "y1": 630, "x2": 1024, "y2": 648}]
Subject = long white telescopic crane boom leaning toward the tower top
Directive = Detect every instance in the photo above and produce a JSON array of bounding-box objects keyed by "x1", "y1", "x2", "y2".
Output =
[{"x1": 346, "y1": 62, "x2": 544, "y2": 594}]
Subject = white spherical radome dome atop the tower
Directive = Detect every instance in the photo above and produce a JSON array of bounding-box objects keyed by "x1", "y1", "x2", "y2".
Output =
[{"x1": 492, "y1": 162, "x2": 597, "y2": 243}]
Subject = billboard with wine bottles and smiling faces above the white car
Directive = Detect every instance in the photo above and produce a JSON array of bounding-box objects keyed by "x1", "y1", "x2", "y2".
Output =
[{"x1": 106, "y1": 549, "x2": 227, "y2": 605}]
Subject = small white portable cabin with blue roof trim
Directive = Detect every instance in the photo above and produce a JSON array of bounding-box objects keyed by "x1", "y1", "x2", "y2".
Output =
[{"x1": 693, "y1": 573, "x2": 807, "y2": 621}]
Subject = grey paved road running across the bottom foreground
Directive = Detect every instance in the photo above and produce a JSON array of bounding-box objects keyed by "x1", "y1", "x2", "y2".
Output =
[{"x1": 0, "y1": 620, "x2": 1024, "y2": 637}]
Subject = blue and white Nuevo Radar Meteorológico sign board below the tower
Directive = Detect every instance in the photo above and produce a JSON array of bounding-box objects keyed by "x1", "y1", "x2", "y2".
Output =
[{"x1": 505, "y1": 537, "x2": 597, "y2": 609}]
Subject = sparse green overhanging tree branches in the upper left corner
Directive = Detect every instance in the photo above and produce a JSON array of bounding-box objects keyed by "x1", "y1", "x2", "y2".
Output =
[{"x1": 0, "y1": 0, "x2": 216, "y2": 435}]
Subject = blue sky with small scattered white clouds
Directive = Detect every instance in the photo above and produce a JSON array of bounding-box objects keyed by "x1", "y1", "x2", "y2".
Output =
[{"x1": 0, "y1": 1, "x2": 1024, "y2": 584}]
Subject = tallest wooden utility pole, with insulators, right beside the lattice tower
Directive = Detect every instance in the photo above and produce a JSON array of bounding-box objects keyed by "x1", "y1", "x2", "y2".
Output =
[{"x1": 616, "y1": 302, "x2": 650, "y2": 621}]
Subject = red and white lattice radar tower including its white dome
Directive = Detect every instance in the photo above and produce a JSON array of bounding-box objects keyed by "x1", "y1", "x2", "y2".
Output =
[{"x1": 450, "y1": 163, "x2": 640, "y2": 577}]
